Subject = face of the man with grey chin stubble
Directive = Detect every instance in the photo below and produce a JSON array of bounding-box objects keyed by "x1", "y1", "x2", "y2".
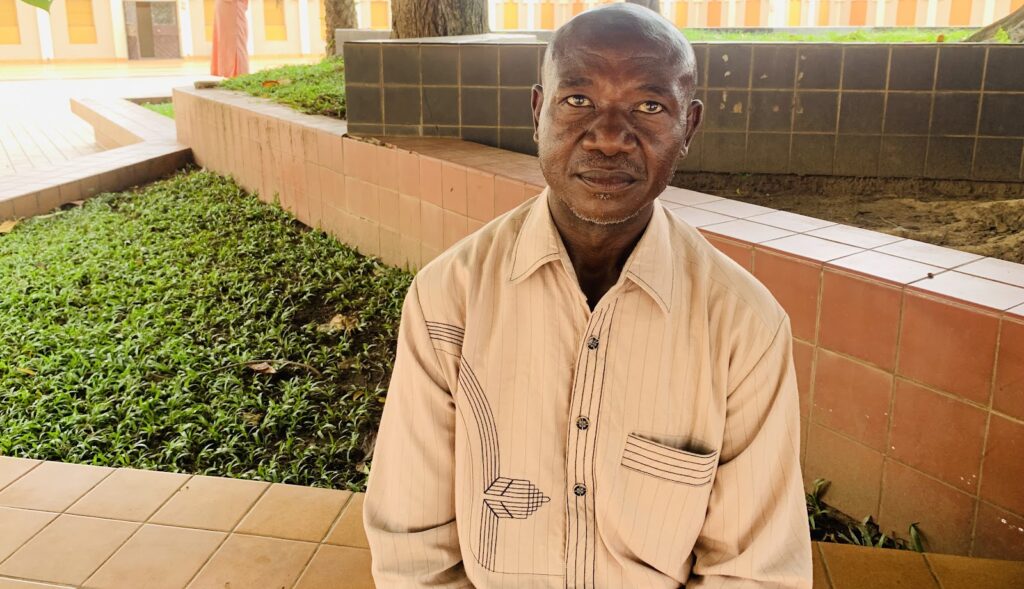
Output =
[{"x1": 534, "y1": 40, "x2": 701, "y2": 224}]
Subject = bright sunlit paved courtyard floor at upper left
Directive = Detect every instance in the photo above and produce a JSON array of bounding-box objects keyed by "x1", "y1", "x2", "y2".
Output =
[{"x1": 0, "y1": 57, "x2": 318, "y2": 176}]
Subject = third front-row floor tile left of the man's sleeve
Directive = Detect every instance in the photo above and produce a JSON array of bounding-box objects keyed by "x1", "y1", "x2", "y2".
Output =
[{"x1": 85, "y1": 525, "x2": 226, "y2": 589}]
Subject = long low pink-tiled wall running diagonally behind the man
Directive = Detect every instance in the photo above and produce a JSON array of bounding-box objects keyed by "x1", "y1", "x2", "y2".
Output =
[{"x1": 174, "y1": 85, "x2": 1024, "y2": 559}]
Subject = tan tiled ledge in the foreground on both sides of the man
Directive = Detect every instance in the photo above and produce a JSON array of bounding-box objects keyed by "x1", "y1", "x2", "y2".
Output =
[{"x1": 0, "y1": 457, "x2": 1024, "y2": 589}]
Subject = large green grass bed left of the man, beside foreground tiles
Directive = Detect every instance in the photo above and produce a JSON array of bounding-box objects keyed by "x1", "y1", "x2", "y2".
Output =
[{"x1": 0, "y1": 171, "x2": 411, "y2": 490}]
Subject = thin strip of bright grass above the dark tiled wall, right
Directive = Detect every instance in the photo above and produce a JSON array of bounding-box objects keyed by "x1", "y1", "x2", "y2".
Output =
[{"x1": 683, "y1": 29, "x2": 976, "y2": 43}]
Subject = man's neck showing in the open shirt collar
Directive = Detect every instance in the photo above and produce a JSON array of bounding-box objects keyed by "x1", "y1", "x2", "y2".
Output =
[{"x1": 548, "y1": 193, "x2": 654, "y2": 310}]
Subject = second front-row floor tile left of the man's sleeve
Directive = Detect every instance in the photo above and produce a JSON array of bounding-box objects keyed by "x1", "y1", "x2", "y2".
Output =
[{"x1": 188, "y1": 534, "x2": 316, "y2": 589}]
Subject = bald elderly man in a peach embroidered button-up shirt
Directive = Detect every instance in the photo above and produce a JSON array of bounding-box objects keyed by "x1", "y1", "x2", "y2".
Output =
[{"x1": 364, "y1": 4, "x2": 811, "y2": 588}]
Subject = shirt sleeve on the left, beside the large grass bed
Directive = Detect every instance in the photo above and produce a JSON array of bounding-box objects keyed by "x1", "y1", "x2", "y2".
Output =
[{"x1": 362, "y1": 281, "x2": 471, "y2": 589}]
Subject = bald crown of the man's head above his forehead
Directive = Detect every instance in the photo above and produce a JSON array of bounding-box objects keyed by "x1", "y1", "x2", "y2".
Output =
[{"x1": 543, "y1": 3, "x2": 696, "y2": 96}]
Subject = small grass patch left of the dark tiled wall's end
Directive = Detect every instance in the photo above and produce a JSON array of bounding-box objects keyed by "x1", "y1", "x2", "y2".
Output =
[{"x1": 221, "y1": 57, "x2": 345, "y2": 119}]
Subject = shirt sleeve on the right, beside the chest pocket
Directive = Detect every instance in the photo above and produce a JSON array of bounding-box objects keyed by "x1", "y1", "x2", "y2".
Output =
[{"x1": 687, "y1": 318, "x2": 812, "y2": 589}]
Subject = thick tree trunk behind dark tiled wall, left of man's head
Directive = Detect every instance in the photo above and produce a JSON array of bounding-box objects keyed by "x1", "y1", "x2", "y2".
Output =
[{"x1": 391, "y1": 0, "x2": 489, "y2": 39}]
